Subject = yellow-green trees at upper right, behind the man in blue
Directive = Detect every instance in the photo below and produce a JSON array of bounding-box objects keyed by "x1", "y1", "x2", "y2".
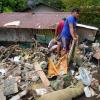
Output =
[{"x1": 62, "y1": 0, "x2": 100, "y2": 26}]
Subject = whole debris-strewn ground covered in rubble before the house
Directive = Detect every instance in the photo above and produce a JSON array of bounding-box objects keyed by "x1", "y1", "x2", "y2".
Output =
[{"x1": 0, "y1": 38, "x2": 100, "y2": 100}]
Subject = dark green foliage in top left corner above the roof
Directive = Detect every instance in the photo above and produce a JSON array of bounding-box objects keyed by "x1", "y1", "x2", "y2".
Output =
[{"x1": 0, "y1": 0, "x2": 27, "y2": 12}]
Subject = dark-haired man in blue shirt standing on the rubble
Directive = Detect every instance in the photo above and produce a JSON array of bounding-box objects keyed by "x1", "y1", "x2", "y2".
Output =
[{"x1": 59, "y1": 9, "x2": 80, "y2": 53}]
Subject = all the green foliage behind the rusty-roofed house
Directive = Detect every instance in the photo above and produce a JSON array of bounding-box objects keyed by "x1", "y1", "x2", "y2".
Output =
[{"x1": 0, "y1": 0, "x2": 100, "y2": 26}]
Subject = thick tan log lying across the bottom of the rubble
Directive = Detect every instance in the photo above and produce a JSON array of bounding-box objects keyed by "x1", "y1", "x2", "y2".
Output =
[{"x1": 39, "y1": 82, "x2": 84, "y2": 100}]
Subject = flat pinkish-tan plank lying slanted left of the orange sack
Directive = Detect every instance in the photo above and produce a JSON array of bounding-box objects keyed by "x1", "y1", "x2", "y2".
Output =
[{"x1": 34, "y1": 62, "x2": 50, "y2": 87}]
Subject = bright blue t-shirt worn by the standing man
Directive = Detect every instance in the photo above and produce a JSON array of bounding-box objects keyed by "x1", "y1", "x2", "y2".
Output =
[{"x1": 60, "y1": 15, "x2": 77, "y2": 40}]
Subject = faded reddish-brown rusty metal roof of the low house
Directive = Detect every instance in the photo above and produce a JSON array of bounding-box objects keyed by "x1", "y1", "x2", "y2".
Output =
[{"x1": 0, "y1": 12, "x2": 70, "y2": 29}]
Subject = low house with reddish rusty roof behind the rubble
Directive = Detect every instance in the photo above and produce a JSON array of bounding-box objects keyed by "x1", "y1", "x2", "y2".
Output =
[{"x1": 0, "y1": 12, "x2": 98, "y2": 43}]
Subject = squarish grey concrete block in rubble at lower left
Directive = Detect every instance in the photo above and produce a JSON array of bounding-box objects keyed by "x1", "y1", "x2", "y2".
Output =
[{"x1": 4, "y1": 78, "x2": 18, "y2": 96}]
